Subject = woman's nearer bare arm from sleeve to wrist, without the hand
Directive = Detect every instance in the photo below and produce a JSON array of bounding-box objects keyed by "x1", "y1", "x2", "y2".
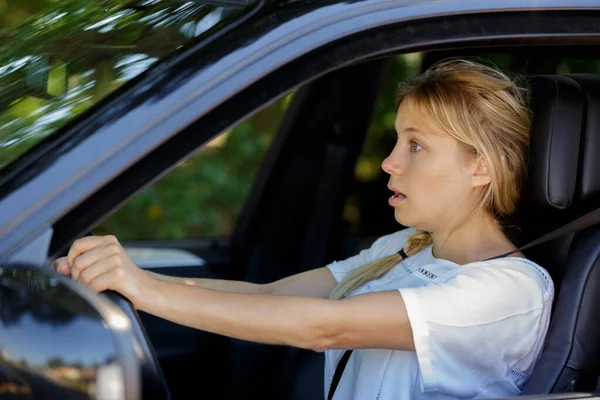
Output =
[{"x1": 134, "y1": 280, "x2": 414, "y2": 351}]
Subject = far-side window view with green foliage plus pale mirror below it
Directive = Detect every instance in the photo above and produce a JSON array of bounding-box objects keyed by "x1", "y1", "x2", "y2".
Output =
[{"x1": 93, "y1": 93, "x2": 294, "y2": 269}]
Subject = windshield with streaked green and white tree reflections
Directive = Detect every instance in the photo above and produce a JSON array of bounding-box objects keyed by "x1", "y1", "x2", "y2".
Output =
[{"x1": 0, "y1": 0, "x2": 255, "y2": 170}]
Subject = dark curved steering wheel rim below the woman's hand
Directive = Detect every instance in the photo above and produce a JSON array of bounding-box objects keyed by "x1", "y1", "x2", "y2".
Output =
[{"x1": 102, "y1": 290, "x2": 171, "y2": 400}]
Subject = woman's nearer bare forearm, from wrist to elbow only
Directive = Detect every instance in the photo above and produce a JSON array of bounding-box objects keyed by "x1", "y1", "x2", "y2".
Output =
[{"x1": 134, "y1": 280, "x2": 338, "y2": 350}]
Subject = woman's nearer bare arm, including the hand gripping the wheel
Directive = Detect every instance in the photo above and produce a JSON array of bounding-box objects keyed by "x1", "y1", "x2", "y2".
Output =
[{"x1": 57, "y1": 236, "x2": 414, "y2": 351}]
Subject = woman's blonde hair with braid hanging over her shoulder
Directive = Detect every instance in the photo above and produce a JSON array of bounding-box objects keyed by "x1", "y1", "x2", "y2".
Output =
[{"x1": 329, "y1": 59, "x2": 531, "y2": 299}]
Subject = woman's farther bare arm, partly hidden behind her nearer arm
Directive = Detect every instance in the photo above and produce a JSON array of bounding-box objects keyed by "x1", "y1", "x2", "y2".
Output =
[{"x1": 146, "y1": 267, "x2": 336, "y2": 298}]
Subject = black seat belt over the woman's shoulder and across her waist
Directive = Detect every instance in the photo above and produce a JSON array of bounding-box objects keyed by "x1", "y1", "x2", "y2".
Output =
[{"x1": 327, "y1": 208, "x2": 600, "y2": 400}]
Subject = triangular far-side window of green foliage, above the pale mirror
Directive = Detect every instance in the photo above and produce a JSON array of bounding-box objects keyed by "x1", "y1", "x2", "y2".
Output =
[{"x1": 93, "y1": 92, "x2": 293, "y2": 240}]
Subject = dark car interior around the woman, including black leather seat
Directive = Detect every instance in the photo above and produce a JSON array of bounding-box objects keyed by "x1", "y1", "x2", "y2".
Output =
[{"x1": 71, "y1": 46, "x2": 600, "y2": 399}]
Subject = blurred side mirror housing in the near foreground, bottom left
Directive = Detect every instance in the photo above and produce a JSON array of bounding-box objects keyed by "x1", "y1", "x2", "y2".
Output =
[{"x1": 0, "y1": 265, "x2": 141, "y2": 400}]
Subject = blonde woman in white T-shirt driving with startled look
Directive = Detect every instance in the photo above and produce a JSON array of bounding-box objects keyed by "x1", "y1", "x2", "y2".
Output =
[{"x1": 54, "y1": 60, "x2": 554, "y2": 399}]
